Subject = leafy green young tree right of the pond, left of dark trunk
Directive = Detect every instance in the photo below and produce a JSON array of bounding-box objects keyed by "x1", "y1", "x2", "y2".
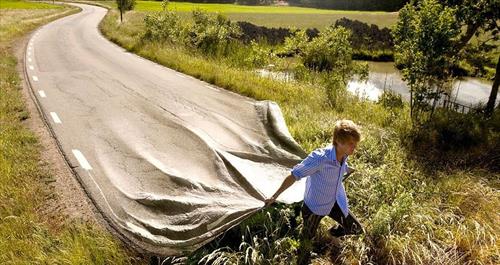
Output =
[{"x1": 392, "y1": 0, "x2": 460, "y2": 124}]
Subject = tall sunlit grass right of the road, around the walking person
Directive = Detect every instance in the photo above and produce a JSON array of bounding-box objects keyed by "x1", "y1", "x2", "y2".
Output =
[{"x1": 100, "y1": 8, "x2": 500, "y2": 264}]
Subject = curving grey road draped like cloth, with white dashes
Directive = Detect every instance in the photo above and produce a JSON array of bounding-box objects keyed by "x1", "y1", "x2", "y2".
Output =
[{"x1": 25, "y1": 5, "x2": 304, "y2": 255}]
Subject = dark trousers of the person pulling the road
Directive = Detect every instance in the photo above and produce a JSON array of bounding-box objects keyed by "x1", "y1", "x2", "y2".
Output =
[{"x1": 297, "y1": 203, "x2": 363, "y2": 265}]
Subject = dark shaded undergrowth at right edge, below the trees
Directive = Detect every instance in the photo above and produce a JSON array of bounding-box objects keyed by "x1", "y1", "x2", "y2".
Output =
[{"x1": 402, "y1": 110, "x2": 500, "y2": 173}]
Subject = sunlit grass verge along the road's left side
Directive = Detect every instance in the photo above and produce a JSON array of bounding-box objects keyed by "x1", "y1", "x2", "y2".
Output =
[{"x1": 0, "y1": 0, "x2": 137, "y2": 264}]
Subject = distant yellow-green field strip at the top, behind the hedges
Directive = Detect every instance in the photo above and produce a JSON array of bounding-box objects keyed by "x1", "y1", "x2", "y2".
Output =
[{"x1": 93, "y1": 1, "x2": 398, "y2": 29}]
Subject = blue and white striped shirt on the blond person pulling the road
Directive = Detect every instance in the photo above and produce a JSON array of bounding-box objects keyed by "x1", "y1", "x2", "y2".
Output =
[{"x1": 292, "y1": 145, "x2": 349, "y2": 216}]
